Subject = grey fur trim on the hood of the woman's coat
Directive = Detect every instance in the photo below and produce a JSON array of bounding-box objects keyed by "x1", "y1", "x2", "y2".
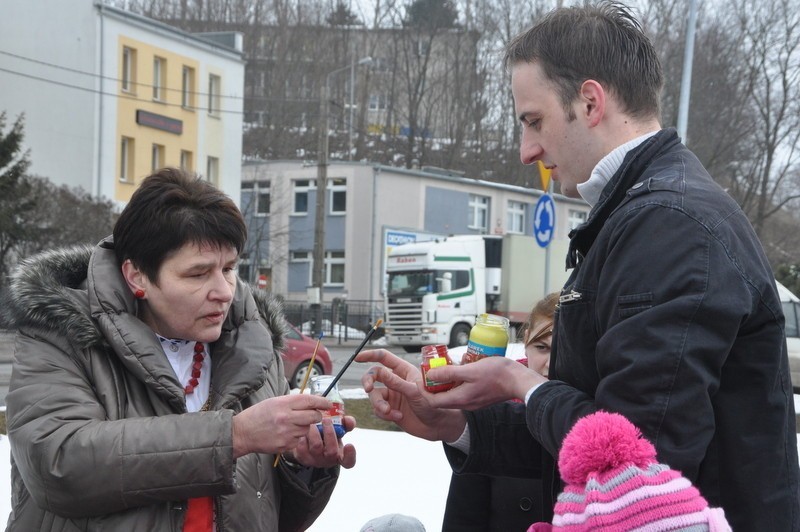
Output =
[{"x1": 2, "y1": 242, "x2": 286, "y2": 351}]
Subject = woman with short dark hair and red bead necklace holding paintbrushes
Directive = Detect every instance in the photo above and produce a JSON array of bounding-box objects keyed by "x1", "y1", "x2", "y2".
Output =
[{"x1": 6, "y1": 169, "x2": 355, "y2": 532}]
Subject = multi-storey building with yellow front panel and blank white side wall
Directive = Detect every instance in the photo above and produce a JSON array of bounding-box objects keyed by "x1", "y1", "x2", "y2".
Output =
[{"x1": 0, "y1": 0, "x2": 244, "y2": 204}]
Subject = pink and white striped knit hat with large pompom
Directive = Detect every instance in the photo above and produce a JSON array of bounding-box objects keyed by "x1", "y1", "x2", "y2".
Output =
[{"x1": 528, "y1": 411, "x2": 731, "y2": 532}]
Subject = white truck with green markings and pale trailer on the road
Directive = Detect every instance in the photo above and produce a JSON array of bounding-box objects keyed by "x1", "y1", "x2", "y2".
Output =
[{"x1": 384, "y1": 234, "x2": 569, "y2": 352}]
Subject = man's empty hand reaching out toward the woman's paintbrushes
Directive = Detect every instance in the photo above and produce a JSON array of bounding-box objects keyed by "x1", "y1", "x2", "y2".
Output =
[{"x1": 355, "y1": 349, "x2": 466, "y2": 442}]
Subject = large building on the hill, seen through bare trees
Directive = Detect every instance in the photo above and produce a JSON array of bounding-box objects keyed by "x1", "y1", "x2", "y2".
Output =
[{"x1": 245, "y1": 26, "x2": 481, "y2": 147}]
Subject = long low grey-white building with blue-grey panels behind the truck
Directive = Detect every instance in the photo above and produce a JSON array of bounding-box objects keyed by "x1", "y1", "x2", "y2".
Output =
[{"x1": 239, "y1": 161, "x2": 589, "y2": 302}]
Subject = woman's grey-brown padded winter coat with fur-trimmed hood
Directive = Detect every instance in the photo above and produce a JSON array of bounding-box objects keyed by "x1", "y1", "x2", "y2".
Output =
[{"x1": 4, "y1": 239, "x2": 338, "y2": 532}]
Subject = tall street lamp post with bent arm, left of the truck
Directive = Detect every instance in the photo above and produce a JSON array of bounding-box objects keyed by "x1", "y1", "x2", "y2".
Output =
[{"x1": 309, "y1": 57, "x2": 372, "y2": 335}]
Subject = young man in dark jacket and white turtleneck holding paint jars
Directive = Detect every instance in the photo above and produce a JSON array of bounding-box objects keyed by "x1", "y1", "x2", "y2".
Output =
[{"x1": 357, "y1": 3, "x2": 800, "y2": 530}]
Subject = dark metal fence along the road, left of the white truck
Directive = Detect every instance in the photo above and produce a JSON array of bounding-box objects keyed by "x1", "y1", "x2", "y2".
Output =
[{"x1": 283, "y1": 299, "x2": 384, "y2": 342}]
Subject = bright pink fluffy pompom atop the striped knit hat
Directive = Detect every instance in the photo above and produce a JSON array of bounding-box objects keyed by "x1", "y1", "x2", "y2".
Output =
[{"x1": 558, "y1": 411, "x2": 656, "y2": 484}]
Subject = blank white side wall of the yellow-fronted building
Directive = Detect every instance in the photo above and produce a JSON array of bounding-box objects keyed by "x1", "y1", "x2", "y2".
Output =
[{"x1": 0, "y1": 0, "x2": 99, "y2": 190}]
